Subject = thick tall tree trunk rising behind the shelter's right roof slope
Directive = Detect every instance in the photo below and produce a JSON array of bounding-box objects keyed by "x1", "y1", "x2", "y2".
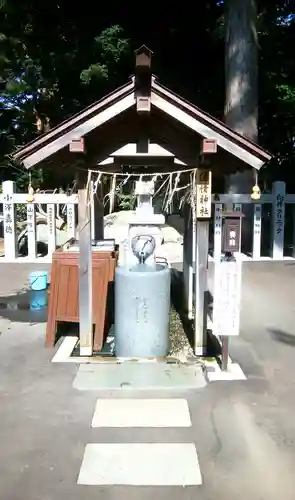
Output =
[{"x1": 224, "y1": 0, "x2": 258, "y2": 251}]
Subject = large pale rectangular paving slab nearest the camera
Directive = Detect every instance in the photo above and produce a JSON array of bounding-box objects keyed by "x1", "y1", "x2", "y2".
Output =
[{"x1": 78, "y1": 443, "x2": 202, "y2": 486}]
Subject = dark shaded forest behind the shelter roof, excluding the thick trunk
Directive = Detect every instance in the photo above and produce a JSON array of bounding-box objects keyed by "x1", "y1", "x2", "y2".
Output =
[{"x1": 0, "y1": 0, "x2": 295, "y2": 192}]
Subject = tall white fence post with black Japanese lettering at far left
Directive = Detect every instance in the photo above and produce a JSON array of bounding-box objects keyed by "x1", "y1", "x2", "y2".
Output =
[{"x1": 2, "y1": 181, "x2": 17, "y2": 260}]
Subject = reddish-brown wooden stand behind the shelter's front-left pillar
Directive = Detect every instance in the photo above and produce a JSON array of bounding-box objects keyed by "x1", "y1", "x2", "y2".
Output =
[{"x1": 46, "y1": 249, "x2": 118, "y2": 351}]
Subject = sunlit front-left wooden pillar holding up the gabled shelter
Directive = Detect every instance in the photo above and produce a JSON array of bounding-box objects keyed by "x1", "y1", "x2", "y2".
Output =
[{"x1": 77, "y1": 171, "x2": 93, "y2": 356}]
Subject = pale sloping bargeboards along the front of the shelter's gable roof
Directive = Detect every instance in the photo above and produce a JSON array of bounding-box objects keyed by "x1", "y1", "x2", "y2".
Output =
[{"x1": 14, "y1": 77, "x2": 271, "y2": 170}]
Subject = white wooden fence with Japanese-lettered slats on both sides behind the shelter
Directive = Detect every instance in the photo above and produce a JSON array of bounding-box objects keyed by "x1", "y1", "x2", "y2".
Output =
[{"x1": 0, "y1": 181, "x2": 295, "y2": 262}]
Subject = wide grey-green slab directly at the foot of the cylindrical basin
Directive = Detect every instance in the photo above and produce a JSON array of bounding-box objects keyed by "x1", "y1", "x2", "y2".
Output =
[{"x1": 73, "y1": 362, "x2": 206, "y2": 391}]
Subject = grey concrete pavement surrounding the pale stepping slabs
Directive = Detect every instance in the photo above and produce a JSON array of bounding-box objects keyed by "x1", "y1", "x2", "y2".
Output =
[{"x1": 0, "y1": 263, "x2": 295, "y2": 500}]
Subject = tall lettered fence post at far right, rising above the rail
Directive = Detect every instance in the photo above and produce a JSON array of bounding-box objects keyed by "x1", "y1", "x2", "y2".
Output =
[{"x1": 272, "y1": 181, "x2": 286, "y2": 260}]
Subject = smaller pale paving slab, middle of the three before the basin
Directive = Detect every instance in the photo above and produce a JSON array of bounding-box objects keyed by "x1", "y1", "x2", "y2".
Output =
[{"x1": 92, "y1": 399, "x2": 192, "y2": 427}]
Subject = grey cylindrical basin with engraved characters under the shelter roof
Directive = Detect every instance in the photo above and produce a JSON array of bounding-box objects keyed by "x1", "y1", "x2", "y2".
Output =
[{"x1": 115, "y1": 264, "x2": 171, "y2": 357}]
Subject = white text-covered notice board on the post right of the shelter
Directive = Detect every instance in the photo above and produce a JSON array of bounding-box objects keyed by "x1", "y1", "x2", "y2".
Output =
[{"x1": 213, "y1": 260, "x2": 242, "y2": 337}]
